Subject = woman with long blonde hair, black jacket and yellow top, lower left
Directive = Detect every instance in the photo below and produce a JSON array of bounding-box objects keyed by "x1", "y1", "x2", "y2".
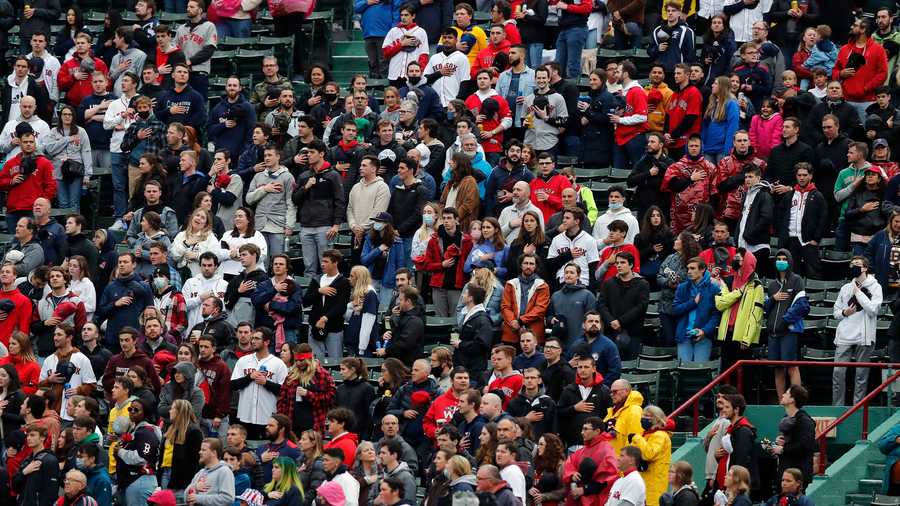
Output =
[{"x1": 159, "y1": 399, "x2": 203, "y2": 490}]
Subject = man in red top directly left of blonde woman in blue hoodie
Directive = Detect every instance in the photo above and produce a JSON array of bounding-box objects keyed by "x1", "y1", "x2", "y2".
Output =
[{"x1": 664, "y1": 63, "x2": 703, "y2": 156}]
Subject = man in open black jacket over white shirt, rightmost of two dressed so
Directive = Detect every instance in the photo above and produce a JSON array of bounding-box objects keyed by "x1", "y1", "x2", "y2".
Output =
[{"x1": 775, "y1": 162, "x2": 831, "y2": 279}]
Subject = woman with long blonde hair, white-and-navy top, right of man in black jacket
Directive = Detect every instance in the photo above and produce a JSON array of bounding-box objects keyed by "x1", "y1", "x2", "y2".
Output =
[{"x1": 344, "y1": 265, "x2": 378, "y2": 356}]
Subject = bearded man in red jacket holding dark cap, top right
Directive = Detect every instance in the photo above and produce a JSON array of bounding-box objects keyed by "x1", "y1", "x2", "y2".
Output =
[{"x1": 831, "y1": 18, "x2": 888, "y2": 121}]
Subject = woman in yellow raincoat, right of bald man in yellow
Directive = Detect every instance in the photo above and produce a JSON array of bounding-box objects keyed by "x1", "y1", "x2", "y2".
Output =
[{"x1": 631, "y1": 405, "x2": 672, "y2": 506}]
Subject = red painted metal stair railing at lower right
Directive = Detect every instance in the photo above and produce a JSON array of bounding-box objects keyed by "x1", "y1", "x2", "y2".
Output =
[{"x1": 669, "y1": 360, "x2": 900, "y2": 458}]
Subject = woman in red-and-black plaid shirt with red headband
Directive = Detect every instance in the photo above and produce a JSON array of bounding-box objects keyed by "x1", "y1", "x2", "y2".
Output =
[{"x1": 276, "y1": 343, "x2": 335, "y2": 434}]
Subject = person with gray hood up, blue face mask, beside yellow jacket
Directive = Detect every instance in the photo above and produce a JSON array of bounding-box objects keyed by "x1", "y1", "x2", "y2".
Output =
[{"x1": 765, "y1": 249, "x2": 809, "y2": 338}]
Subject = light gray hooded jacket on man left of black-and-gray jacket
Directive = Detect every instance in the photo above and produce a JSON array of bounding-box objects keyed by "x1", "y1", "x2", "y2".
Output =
[{"x1": 247, "y1": 165, "x2": 297, "y2": 234}]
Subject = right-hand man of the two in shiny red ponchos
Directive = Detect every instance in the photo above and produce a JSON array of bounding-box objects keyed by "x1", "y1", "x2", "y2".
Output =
[{"x1": 713, "y1": 130, "x2": 767, "y2": 230}]
